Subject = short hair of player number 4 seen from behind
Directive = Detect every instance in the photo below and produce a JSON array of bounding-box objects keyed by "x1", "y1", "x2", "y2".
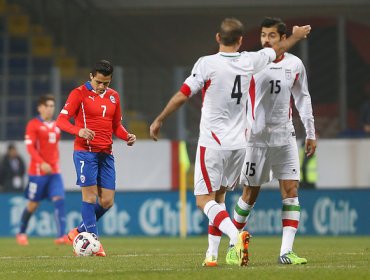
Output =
[{"x1": 218, "y1": 18, "x2": 244, "y2": 46}]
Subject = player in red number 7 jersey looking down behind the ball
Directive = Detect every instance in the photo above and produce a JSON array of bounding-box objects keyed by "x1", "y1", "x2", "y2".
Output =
[{"x1": 57, "y1": 60, "x2": 136, "y2": 257}]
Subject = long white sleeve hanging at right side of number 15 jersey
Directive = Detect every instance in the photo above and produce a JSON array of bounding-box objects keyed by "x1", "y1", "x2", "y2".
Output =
[{"x1": 292, "y1": 61, "x2": 316, "y2": 139}]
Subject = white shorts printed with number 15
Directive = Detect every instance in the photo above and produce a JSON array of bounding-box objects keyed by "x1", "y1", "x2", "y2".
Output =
[{"x1": 240, "y1": 141, "x2": 300, "y2": 187}]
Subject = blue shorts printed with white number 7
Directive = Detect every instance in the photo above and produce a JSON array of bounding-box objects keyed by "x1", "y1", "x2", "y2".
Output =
[{"x1": 73, "y1": 151, "x2": 116, "y2": 190}]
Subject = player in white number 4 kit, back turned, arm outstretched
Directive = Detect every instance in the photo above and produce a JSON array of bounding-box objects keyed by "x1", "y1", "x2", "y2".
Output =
[{"x1": 150, "y1": 18, "x2": 311, "y2": 266}]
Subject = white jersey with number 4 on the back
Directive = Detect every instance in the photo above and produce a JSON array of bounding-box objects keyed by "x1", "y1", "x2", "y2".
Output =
[{"x1": 181, "y1": 48, "x2": 276, "y2": 150}]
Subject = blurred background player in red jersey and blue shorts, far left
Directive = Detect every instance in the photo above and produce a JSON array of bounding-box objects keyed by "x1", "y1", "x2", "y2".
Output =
[{"x1": 16, "y1": 95, "x2": 70, "y2": 245}]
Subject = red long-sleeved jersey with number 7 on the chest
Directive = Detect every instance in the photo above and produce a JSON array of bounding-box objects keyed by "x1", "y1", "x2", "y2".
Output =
[{"x1": 57, "y1": 82, "x2": 127, "y2": 153}]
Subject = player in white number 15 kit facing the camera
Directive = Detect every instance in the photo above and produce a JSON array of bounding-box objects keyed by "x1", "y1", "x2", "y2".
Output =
[{"x1": 233, "y1": 18, "x2": 316, "y2": 264}]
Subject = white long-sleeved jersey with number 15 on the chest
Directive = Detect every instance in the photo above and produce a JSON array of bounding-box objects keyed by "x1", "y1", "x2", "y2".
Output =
[{"x1": 247, "y1": 53, "x2": 315, "y2": 147}]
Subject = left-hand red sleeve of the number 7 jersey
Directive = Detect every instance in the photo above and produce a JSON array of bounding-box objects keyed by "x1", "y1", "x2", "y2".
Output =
[{"x1": 57, "y1": 89, "x2": 82, "y2": 135}]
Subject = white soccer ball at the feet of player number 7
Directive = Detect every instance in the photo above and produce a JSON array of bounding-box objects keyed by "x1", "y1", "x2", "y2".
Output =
[{"x1": 73, "y1": 232, "x2": 100, "y2": 257}]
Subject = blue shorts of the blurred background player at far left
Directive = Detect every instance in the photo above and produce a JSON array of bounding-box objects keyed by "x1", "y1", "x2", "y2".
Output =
[{"x1": 25, "y1": 173, "x2": 64, "y2": 201}]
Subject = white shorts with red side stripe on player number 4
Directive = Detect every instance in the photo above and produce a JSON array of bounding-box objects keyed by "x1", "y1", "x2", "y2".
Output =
[{"x1": 194, "y1": 145, "x2": 245, "y2": 195}]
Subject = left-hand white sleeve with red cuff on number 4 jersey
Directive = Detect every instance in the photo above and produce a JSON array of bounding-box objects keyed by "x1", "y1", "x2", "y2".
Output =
[{"x1": 180, "y1": 57, "x2": 208, "y2": 97}]
